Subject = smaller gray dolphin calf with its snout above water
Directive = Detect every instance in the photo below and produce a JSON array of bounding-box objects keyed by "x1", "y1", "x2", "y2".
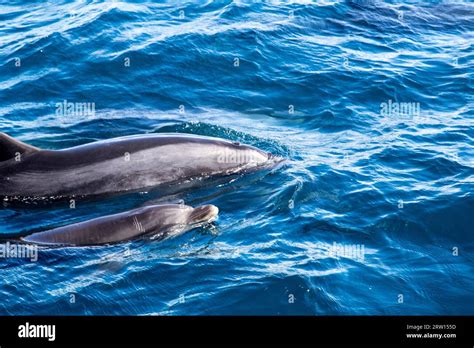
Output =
[{"x1": 21, "y1": 204, "x2": 219, "y2": 246}]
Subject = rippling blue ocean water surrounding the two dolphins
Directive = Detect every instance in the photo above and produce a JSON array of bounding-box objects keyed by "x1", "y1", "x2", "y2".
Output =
[{"x1": 0, "y1": 1, "x2": 474, "y2": 315}]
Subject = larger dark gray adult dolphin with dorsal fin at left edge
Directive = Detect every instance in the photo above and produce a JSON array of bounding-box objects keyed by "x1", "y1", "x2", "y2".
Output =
[{"x1": 0, "y1": 133, "x2": 281, "y2": 199}]
